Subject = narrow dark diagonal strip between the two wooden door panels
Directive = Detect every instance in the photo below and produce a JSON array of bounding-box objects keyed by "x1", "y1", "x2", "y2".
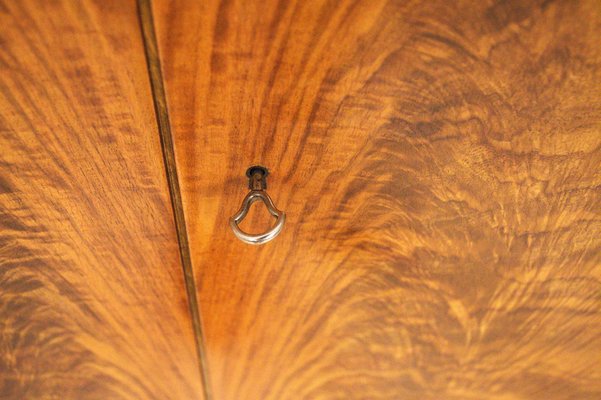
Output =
[{"x1": 137, "y1": 0, "x2": 211, "y2": 400}]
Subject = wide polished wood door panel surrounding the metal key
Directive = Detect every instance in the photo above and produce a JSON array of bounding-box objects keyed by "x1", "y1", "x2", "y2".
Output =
[{"x1": 154, "y1": 0, "x2": 601, "y2": 400}]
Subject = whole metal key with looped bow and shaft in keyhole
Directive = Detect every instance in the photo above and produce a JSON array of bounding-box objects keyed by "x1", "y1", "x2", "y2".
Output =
[{"x1": 230, "y1": 166, "x2": 286, "y2": 245}]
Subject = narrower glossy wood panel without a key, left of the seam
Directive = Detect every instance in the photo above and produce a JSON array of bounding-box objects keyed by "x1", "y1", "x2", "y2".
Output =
[{"x1": 0, "y1": 0, "x2": 202, "y2": 400}]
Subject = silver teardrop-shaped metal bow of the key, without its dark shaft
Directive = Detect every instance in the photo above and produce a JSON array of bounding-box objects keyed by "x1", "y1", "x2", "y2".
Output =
[{"x1": 230, "y1": 190, "x2": 286, "y2": 245}]
